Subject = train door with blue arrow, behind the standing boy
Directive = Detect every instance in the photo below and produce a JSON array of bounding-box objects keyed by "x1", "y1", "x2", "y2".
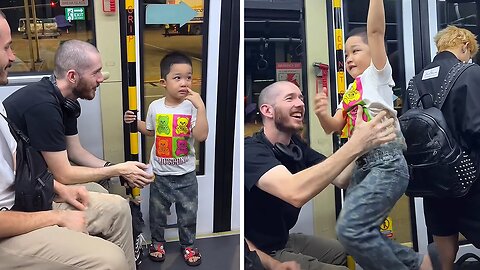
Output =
[{"x1": 121, "y1": 0, "x2": 240, "y2": 239}]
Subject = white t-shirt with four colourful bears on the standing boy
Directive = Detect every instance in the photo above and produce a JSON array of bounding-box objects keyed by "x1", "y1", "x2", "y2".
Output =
[{"x1": 145, "y1": 98, "x2": 197, "y2": 175}]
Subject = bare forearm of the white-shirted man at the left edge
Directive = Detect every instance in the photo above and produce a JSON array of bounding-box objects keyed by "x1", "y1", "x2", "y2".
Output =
[{"x1": 0, "y1": 210, "x2": 60, "y2": 238}]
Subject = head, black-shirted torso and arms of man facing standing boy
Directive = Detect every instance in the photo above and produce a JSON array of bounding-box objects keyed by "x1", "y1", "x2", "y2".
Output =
[{"x1": 3, "y1": 40, "x2": 153, "y2": 191}]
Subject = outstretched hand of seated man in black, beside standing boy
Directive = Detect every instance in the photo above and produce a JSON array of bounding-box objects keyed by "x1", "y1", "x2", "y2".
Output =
[{"x1": 116, "y1": 161, "x2": 155, "y2": 188}]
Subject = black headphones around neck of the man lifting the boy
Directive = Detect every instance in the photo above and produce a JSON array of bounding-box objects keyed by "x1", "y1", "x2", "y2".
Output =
[{"x1": 253, "y1": 129, "x2": 303, "y2": 163}]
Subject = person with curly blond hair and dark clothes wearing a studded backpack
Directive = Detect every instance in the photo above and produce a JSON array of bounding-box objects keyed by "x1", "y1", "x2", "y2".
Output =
[{"x1": 403, "y1": 26, "x2": 480, "y2": 270}]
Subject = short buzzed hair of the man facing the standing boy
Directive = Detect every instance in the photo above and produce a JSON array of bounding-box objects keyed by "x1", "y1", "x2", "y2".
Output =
[{"x1": 54, "y1": 40, "x2": 98, "y2": 78}]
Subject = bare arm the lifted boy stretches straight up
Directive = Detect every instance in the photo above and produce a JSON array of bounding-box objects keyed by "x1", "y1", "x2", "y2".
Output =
[{"x1": 367, "y1": 0, "x2": 387, "y2": 70}]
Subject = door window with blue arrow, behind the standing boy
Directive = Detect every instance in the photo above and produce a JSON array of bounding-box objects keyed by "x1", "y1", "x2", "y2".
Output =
[{"x1": 143, "y1": 0, "x2": 208, "y2": 174}]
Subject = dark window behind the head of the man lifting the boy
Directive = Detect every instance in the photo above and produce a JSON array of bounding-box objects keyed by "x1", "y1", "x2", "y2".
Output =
[{"x1": 244, "y1": 6, "x2": 308, "y2": 136}]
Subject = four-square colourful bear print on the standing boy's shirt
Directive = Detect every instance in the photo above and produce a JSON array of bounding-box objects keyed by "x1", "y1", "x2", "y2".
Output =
[{"x1": 155, "y1": 114, "x2": 192, "y2": 165}]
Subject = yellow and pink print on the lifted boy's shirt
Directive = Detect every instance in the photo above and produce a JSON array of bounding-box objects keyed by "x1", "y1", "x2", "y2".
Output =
[{"x1": 342, "y1": 77, "x2": 372, "y2": 138}]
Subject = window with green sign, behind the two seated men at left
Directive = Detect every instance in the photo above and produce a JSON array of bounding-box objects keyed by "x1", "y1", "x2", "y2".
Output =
[{"x1": 0, "y1": 0, "x2": 94, "y2": 75}]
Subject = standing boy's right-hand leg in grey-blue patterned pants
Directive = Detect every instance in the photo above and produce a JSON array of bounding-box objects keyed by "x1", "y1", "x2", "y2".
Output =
[{"x1": 175, "y1": 172, "x2": 198, "y2": 248}]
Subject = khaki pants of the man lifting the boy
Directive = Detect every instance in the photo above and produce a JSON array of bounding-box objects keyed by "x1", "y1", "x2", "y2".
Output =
[{"x1": 272, "y1": 234, "x2": 348, "y2": 270}]
